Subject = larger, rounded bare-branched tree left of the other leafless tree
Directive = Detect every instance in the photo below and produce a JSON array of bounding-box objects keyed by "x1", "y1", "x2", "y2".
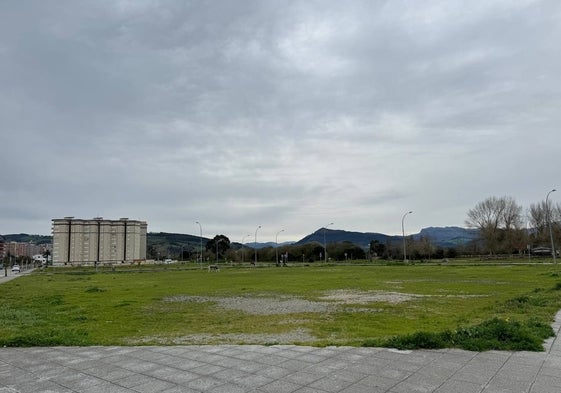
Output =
[{"x1": 466, "y1": 196, "x2": 522, "y2": 254}]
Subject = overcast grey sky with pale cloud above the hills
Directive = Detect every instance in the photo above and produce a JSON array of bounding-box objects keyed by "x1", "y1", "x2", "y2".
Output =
[{"x1": 0, "y1": 0, "x2": 561, "y2": 242}]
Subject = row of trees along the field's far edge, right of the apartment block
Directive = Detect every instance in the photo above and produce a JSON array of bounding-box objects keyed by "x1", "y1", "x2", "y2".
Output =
[{"x1": 148, "y1": 196, "x2": 561, "y2": 264}]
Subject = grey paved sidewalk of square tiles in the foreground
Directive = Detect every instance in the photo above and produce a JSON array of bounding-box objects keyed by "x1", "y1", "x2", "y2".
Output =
[{"x1": 0, "y1": 312, "x2": 561, "y2": 393}]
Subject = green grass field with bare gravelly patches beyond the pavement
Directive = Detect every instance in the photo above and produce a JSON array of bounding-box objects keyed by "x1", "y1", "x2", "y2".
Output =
[{"x1": 0, "y1": 264, "x2": 561, "y2": 350}]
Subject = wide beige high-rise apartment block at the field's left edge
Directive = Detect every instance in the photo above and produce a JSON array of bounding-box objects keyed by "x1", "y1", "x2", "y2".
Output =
[{"x1": 52, "y1": 217, "x2": 147, "y2": 266}]
